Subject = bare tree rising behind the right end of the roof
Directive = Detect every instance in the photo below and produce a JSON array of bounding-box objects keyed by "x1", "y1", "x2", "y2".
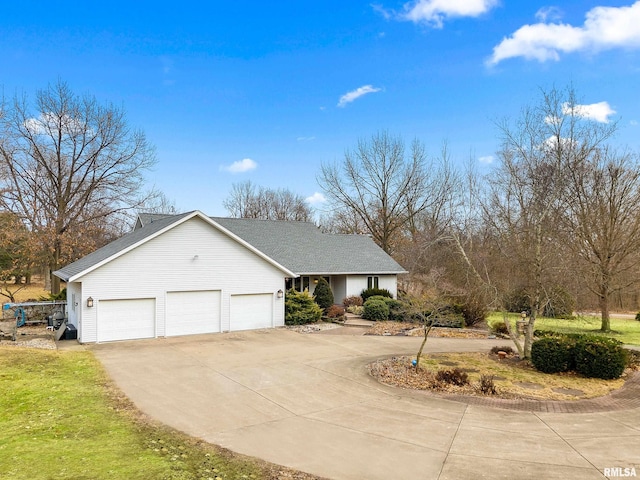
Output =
[{"x1": 318, "y1": 132, "x2": 448, "y2": 253}]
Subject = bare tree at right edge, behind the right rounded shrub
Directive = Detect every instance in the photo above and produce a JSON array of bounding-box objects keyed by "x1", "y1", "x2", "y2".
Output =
[{"x1": 563, "y1": 148, "x2": 640, "y2": 332}]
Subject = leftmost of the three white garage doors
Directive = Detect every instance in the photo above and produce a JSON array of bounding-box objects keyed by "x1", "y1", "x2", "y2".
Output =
[{"x1": 97, "y1": 298, "x2": 156, "y2": 342}]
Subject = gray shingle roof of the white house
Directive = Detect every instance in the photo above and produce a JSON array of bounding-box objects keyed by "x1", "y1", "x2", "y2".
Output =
[{"x1": 54, "y1": 212, "x2": 405, "y2": 281}]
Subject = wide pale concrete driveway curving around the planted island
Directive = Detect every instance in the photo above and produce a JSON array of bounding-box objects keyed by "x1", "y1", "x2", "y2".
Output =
[{"x1": 91, "y1": 327, "x2": 640, "y2": 480}]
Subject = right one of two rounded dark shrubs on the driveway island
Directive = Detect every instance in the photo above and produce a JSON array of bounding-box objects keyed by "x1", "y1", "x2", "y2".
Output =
[{"x1": 572, "y1": 337, "x2": 628, "y2": 380}]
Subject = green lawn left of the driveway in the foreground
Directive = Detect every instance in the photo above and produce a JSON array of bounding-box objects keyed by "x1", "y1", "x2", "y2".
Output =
[{"x1": 0, "y1": 346, "x2": 278, "y2": 480}]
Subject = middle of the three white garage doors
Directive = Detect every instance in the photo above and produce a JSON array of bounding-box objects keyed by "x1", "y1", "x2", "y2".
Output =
[{"x1": 165, "y1": 290, "x2": 221, "y2": 337}]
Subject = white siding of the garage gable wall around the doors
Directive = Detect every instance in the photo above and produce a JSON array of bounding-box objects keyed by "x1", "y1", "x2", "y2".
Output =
[{"x1": 70, "y1": 217, "x2": 284, "y2": 343}]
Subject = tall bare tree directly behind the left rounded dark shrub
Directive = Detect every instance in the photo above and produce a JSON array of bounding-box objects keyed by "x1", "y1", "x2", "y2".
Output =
[{"x1": 486, "y1": 88, "x2": 616, "y2": 358}]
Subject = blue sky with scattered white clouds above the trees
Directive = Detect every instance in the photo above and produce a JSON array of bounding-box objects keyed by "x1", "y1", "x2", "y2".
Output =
[{"x1": 0, "y1": 0, "x2": 640, "y2": 215}]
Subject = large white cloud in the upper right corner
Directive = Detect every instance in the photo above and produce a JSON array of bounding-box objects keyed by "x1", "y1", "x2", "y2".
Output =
[{"x1": 487, "y1": 0, "x2": 640, "y2": 65}]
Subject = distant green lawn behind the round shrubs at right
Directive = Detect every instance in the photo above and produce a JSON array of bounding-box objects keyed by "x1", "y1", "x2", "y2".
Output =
[{"x1": 487, "y1": 312, "x2": 640, "y2": 345}]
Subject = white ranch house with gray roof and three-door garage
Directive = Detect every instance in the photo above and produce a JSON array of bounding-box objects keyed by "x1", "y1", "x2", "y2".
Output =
[{"x1": 54, "y1": 211, "x2": 404, "y2": 343}]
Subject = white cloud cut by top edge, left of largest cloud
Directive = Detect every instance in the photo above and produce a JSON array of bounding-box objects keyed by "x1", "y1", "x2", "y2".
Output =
[{"x1": 399, "y1": 0, "x2": 498, "y2": 28}]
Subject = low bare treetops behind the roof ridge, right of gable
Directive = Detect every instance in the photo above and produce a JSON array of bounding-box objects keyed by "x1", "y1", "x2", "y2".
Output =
[{"x1": 222, "y1": 181, "x2": 313, "y2": 222}]
